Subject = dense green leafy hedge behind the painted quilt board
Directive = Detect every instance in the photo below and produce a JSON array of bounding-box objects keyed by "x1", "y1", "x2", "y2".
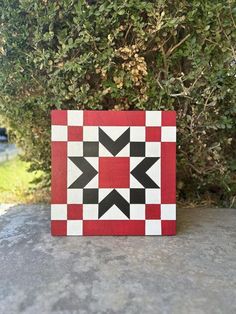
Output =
[{"x1": 0, "y1": 0, "x2": 236, "y2": 205}]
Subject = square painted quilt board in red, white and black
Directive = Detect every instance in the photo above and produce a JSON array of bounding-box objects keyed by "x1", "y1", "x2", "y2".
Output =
[{"x1": 51, "y1": 110, "x2": 176, "y2": 236}]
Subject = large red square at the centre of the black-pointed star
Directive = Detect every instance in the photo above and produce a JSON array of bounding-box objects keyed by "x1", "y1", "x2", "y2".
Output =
[{"x1": 99, "y1": 157, "x2": 130, "y2": 188}]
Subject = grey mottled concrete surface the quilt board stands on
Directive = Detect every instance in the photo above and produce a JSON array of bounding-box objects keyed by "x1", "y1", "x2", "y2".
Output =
[{"x1": 0, "y1": 205, "x2": 236, "y2": 314}]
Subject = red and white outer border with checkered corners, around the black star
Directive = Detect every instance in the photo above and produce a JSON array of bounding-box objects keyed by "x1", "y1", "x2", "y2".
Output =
[{"x1": 51, "y1": 110, "x2": 176, "y2": 236}]
